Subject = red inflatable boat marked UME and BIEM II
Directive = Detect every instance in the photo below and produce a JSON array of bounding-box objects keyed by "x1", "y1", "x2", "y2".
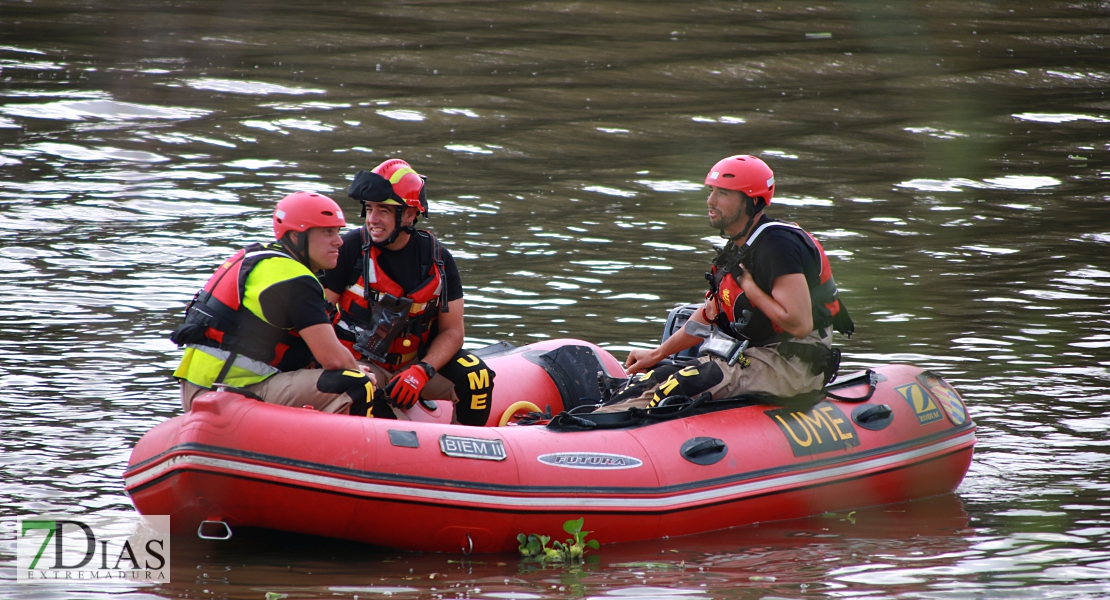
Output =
[{"x1": 124, "y1": 339, "x2": 976, "y2": 552}]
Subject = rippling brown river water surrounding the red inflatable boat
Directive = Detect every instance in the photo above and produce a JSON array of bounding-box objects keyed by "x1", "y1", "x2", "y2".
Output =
[{"x1": 0, "y1": 0, "x2": 1110, "y2": 599}]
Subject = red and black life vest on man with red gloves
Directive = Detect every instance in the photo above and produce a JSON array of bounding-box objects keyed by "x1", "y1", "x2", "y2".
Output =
[{"x1": 335, "y1": 227, "x2": 446, "y2": 370}]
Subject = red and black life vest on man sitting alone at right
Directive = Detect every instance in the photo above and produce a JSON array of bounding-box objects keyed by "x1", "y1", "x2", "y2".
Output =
[{"x1": 709, "y1": 218, "x2": 855, "y2": 346}]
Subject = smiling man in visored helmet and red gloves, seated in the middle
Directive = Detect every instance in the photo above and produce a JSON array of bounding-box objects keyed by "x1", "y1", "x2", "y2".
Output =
[{"x1": 323, "y1": 159, "x2": 494, "y2": 426}]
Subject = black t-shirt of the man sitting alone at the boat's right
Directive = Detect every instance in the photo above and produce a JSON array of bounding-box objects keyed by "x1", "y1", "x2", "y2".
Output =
[{"x1": 735, "y1": 217, "x2": 821, "y2": 346}]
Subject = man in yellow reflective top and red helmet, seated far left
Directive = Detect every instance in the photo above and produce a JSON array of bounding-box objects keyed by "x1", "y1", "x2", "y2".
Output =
[{"x1": 170, "y1": 192, "x2": 392, "y2": 416}]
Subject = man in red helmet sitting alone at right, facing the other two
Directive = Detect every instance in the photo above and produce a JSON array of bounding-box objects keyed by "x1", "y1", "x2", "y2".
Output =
[{"x1": 599, "y1": 155, "x2": 854, "y2": 411}]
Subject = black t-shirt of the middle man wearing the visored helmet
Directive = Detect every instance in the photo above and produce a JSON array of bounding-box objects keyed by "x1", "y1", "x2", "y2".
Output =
[{"x1": 324, "y1": 227, "x2": 463, "y2": 302}]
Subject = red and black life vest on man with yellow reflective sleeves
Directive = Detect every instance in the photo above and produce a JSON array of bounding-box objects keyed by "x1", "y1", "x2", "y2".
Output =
[{"x1": 170, "y1": 244, "x2": 311, "y2": 370}]
